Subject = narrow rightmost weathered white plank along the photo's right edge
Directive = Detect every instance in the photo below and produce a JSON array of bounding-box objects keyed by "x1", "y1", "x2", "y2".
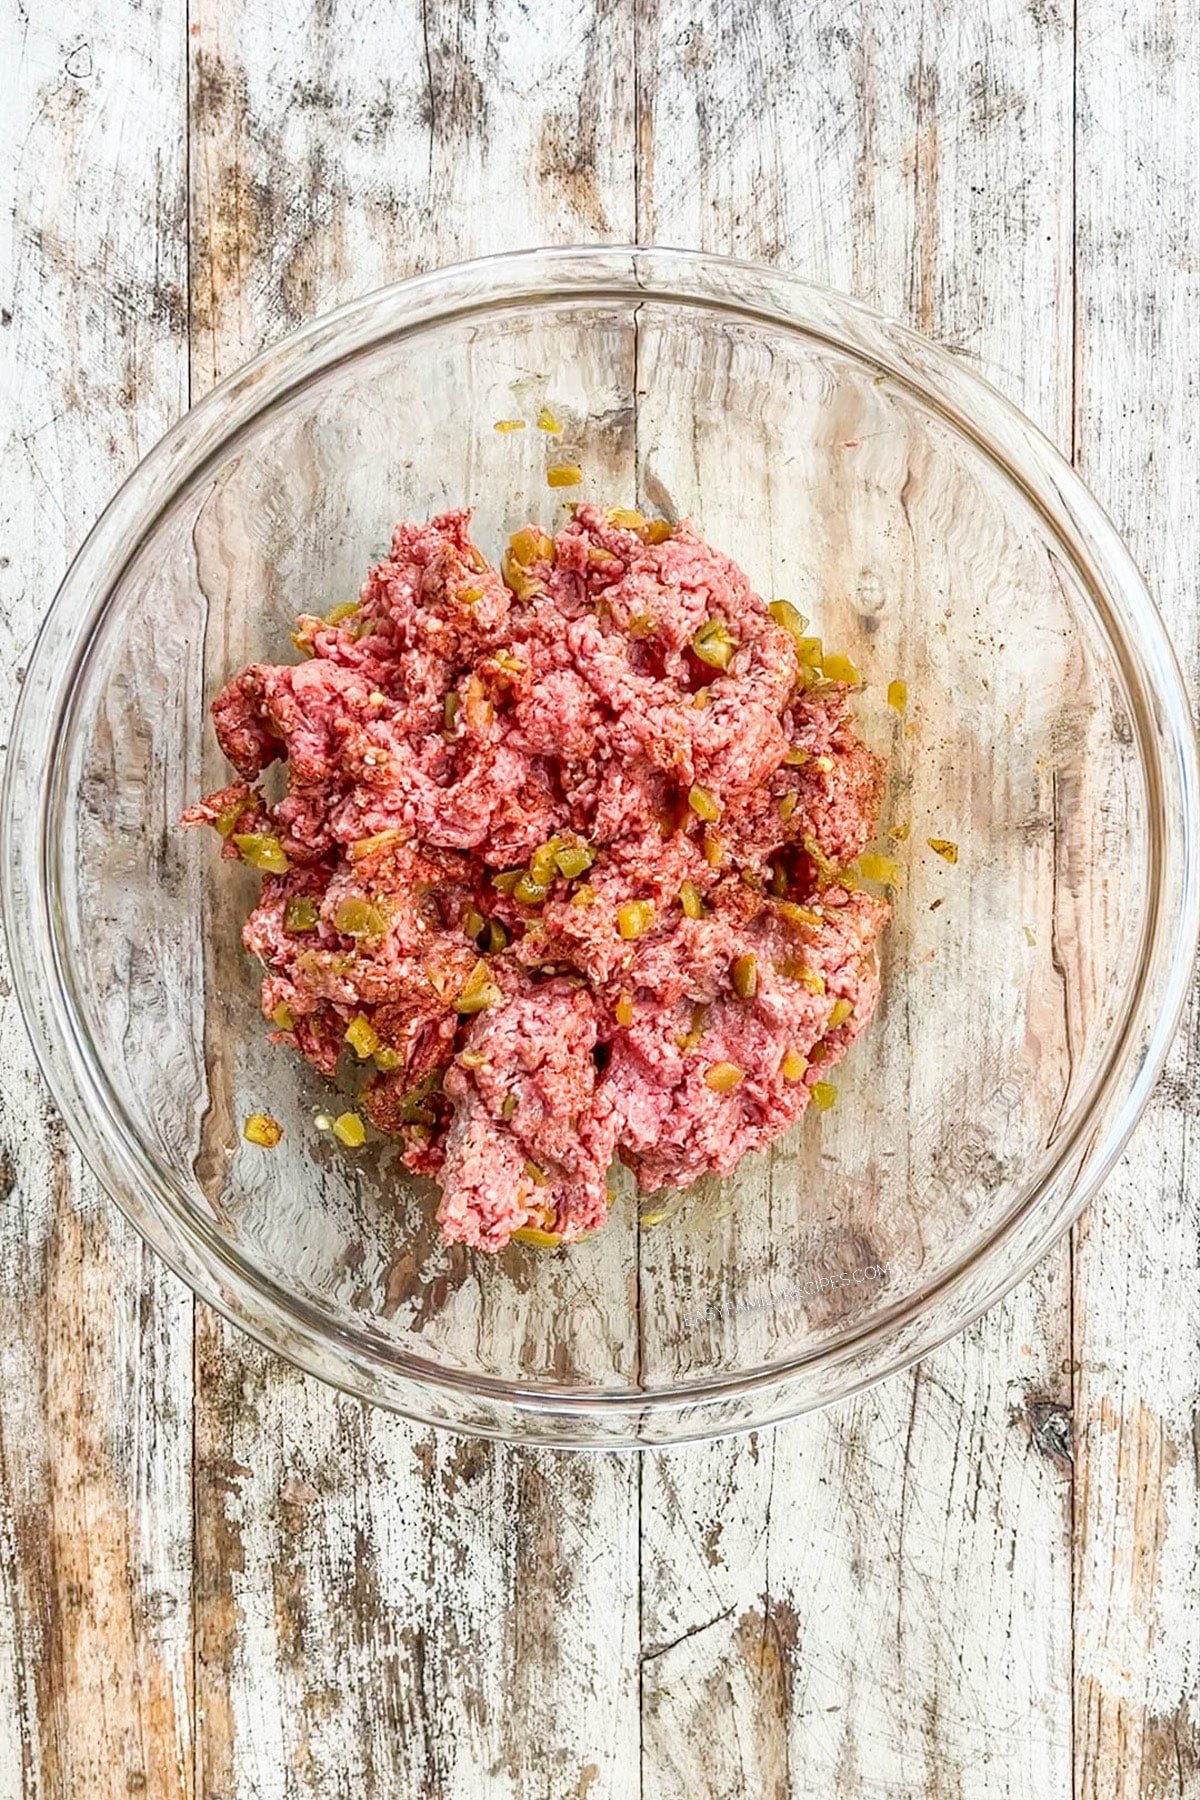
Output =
[{"x1": 1074, "y1": 0, "x2": 1200, "y2": 1800}]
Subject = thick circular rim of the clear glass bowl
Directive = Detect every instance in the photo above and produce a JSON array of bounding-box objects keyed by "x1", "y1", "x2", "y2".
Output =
[{"x1": 0, "y1": 245, "x2": 1200, "y2": 1445}]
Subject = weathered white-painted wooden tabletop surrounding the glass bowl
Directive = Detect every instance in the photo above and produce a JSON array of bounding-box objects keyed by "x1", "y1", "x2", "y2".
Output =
[{"x1": 0, "y1": 0, "x2": 1200, "y2": 1800}]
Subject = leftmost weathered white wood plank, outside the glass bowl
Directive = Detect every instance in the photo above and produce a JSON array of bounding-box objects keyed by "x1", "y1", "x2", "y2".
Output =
[{"x1": 0, "y1": 0, "x2": 193, "y2": 1800}]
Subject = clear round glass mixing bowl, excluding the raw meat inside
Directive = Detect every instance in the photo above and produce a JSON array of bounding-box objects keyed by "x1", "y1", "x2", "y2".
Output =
[{"x1": 4, "y1": 248, "x2": 1196, "y2": 1445}]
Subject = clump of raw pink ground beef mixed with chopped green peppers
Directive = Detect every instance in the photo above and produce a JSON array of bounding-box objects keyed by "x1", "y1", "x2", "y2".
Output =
[{"x1": 185, "y1": 506, "x2": 887, "y2": 1251}]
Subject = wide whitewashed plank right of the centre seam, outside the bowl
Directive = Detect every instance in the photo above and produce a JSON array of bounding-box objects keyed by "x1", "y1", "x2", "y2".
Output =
[{"x1": 639, "y1": 0, "x2": 1072, "y2": 1800}]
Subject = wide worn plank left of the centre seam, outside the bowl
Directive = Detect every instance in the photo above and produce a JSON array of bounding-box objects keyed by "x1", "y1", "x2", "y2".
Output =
[{"x1": 191, "y1": 0, "x2": 639, "y2": 1800}]
